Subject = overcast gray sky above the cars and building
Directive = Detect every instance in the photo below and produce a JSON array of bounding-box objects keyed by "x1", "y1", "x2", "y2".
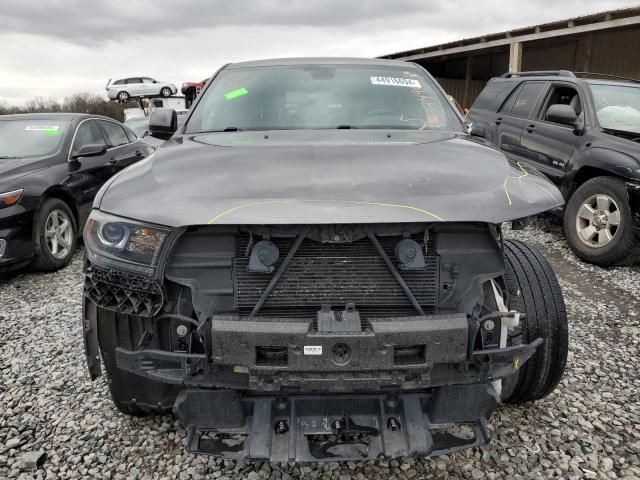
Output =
[{"x1": 0, "y1": 0, "x2": 639, "y2": 104}]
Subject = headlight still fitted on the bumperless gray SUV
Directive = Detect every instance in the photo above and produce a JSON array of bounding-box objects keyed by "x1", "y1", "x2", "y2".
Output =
[{"x1": 84, "y1": 210, "x2": 171, "y2": 267}]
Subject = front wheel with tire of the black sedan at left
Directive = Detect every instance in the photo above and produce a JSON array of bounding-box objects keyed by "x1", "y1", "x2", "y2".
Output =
[{"x1": 33, "y1": 198, "x2": 78, "y2": 272}]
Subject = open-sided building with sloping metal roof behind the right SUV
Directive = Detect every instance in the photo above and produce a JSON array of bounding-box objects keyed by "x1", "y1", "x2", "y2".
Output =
[{"x1": 382, "y1": 7, "x2": 640, "y2": 107}]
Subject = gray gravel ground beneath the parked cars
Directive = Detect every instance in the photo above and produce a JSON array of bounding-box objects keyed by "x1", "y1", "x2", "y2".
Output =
[{"x1": 0, "y1": 220, "x2": 640, "y2": 480}]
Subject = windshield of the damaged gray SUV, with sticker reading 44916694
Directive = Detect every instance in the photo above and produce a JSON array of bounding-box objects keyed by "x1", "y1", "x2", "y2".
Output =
[{"x1": 186, "y1": 65, "x2": 462, "y2": 133}]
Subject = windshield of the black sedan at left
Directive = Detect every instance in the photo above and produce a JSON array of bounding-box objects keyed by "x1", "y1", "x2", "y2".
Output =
[{"x1": 0, "y1": 119, "x2": 69, "y2": 160}]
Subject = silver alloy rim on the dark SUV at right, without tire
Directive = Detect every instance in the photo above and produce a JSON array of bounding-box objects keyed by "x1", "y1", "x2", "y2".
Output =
[{"x1": 576, "y1": 194, "x2": 620, "y2": 248}]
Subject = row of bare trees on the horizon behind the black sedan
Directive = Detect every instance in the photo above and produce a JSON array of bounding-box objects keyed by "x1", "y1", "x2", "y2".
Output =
[{"x1": 0, "y1": 93, "x2": 137, "y2": 122}]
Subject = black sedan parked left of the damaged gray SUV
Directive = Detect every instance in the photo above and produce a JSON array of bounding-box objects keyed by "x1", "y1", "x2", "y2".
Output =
[{"x1": 0, "y1": 113, "x2": 153, "y2": 272}]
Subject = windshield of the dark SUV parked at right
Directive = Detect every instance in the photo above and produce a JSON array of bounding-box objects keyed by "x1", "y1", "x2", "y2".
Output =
[{"x1": 590, "y1": 84, "x2": 640, "y2": 134}]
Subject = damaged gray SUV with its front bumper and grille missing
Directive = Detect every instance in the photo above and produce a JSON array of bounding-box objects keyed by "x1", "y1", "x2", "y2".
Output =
[{"x1": 83, "y1": 59, "x2": 568, "y2": 462}]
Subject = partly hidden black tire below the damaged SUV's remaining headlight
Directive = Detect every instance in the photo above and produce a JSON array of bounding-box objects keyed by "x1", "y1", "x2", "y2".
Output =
[{"x1": 95, "y1": 304, "x2": 180, "y2": 416}]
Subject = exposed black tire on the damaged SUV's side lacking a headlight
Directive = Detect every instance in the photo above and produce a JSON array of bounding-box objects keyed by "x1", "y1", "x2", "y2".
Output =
[{"x1": 501, "y1": 241, "x2": 569, "y2": 403}]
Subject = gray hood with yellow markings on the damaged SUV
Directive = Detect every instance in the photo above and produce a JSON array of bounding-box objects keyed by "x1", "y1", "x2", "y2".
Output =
[{"x1": 95, "y1": 130, "x2": 563, "y2": 227}]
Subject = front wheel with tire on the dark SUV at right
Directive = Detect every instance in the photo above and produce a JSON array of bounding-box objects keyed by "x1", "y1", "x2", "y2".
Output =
[{"x1": 564, "y1": 177, "x2": 640, "y2": 266}]
